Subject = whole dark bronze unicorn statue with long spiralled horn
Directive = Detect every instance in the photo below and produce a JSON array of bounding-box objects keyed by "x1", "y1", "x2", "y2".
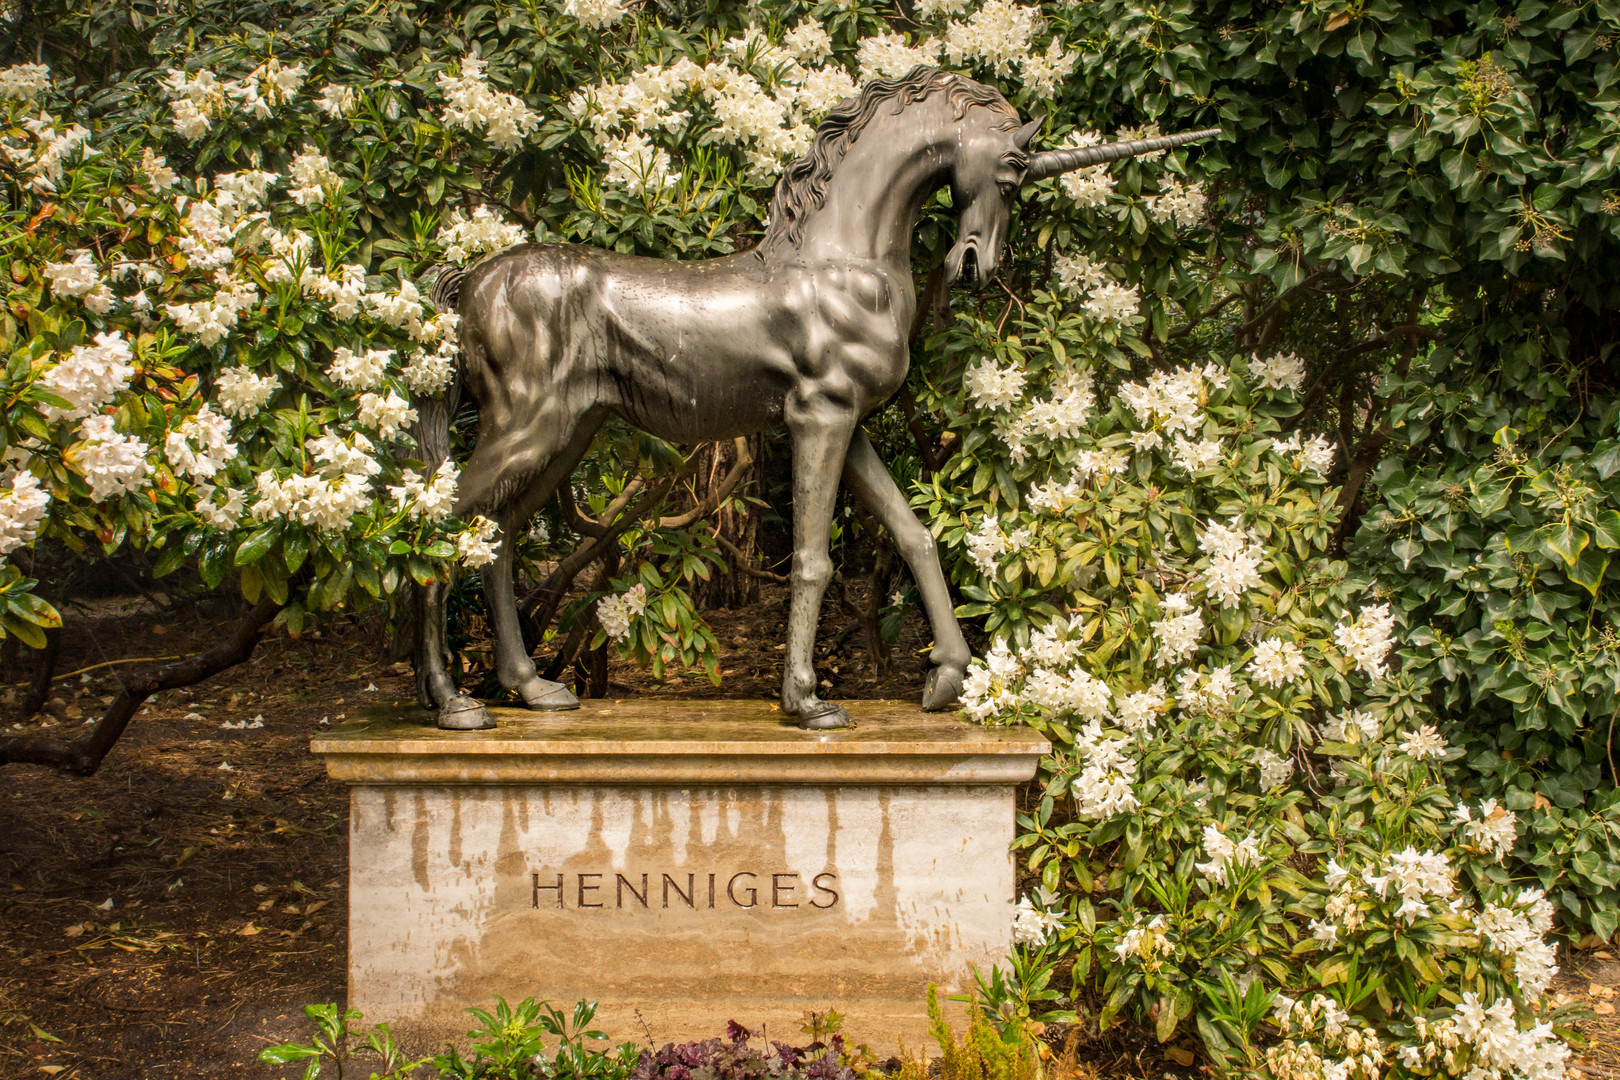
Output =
[{"x1": 405, "y1": 66, "x2": 1220, "y2": 730}]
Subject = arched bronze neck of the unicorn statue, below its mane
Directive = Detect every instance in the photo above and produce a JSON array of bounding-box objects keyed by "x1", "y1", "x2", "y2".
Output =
[{"x1": 780, "y1": 103, "x2": 956, "y2": 272}]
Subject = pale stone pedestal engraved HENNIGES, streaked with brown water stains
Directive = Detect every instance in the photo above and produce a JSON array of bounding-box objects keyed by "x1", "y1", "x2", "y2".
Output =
[{"x1": 311, "y1": 701, "x2": 1047, "y2": 1048}]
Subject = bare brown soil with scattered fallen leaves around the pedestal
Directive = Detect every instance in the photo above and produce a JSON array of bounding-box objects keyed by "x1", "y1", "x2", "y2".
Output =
[{"x1": 0, "y1": 588, "x2": 1620, "y2": 1080}]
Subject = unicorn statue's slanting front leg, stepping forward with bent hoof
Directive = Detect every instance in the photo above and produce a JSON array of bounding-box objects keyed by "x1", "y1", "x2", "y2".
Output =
[{"x1": 844, "y1": 431, "x2": 972, "y2": 711}]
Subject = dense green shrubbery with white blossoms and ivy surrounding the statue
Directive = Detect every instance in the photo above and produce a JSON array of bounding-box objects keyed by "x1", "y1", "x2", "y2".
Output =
[{"x1": 0, "y1": 0, "x2": 1620, "y2": 1080}]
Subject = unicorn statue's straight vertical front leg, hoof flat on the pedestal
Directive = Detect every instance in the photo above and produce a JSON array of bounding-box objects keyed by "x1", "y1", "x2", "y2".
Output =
[{"x1": 782, "y1": 402, "x2": 855, "y2": 730}]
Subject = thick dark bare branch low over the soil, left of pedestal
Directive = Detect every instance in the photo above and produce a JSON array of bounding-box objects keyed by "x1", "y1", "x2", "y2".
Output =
[{"x1": 0, "y1": 597, "x2": 282, "y2": 776}]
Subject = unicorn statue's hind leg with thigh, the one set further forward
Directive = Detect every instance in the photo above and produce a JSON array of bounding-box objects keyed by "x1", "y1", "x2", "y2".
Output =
[{"x1": 457, "y1": 413, "x2": 601, "y2": 722}]
